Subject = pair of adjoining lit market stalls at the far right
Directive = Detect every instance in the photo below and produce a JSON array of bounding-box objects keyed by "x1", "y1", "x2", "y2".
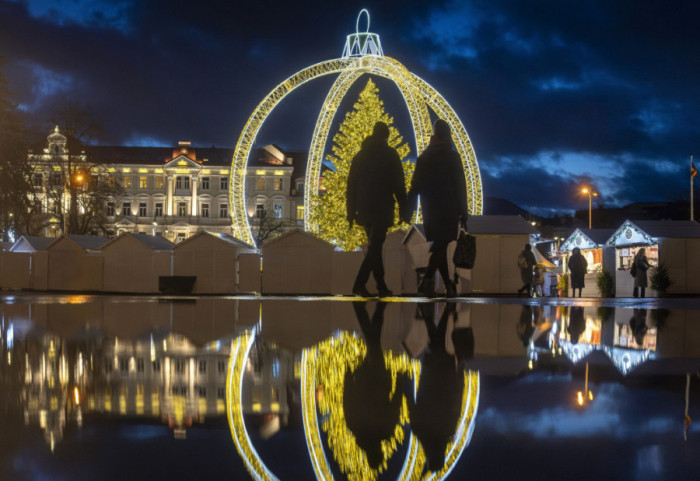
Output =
[{"x1": 559, "y1": 220, "x2": 700, "y2": 297}]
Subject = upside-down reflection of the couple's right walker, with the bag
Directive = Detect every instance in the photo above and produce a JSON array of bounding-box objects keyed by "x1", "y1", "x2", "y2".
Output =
[{"x1": 407, "y1": 303, "x2": 474, "y2": 472}]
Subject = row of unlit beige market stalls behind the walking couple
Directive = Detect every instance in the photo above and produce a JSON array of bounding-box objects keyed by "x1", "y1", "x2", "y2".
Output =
[{"x1": 0, "y1": 216, "x2": 536, "y2": 295}]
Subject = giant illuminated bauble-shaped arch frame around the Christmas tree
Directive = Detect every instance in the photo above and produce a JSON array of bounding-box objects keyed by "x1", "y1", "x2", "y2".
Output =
[{"x1": 229, "y1": 9, "x2": 483, "y2": 245}]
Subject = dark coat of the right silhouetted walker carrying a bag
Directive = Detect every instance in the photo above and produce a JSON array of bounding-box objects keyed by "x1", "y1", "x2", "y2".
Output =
[{"x1": 407, "y1": 137, "x2": 468, "y2": 242}]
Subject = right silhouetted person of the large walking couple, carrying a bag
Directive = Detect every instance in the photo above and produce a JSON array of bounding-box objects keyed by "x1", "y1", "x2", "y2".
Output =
[{"x1": 402, "y1": 119, "x2": 468, "y2": 297}]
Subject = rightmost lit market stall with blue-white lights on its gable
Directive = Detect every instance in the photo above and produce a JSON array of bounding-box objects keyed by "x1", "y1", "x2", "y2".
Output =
[{"x1": 606, "y1": 220, "x2": 700, "y2": 297}]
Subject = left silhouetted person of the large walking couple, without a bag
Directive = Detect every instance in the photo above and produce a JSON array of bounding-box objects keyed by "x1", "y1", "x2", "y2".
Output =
[{"x1": 346, "y1": 122, "x2": 406, "y2": 297}]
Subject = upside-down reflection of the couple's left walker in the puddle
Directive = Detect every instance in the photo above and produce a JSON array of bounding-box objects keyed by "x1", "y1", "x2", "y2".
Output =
[{"x1": 343, "y1": 302, "x2": 403, "y2": 469}]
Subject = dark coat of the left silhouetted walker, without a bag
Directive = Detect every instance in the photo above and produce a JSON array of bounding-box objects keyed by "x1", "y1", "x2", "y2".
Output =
[{"x1": 346, "y1": 135, "x2": 406, "y2": 228}]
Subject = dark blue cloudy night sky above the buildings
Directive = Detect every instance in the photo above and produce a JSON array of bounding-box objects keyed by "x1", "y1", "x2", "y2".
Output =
[{"x1": 0, "y1": 0, "x2": 700, "y2": 215}]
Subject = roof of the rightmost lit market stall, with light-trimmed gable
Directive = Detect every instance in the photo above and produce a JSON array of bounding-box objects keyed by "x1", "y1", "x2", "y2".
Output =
[{"x1": 605, "y1": 220, "x2": 700, "y2": 246}]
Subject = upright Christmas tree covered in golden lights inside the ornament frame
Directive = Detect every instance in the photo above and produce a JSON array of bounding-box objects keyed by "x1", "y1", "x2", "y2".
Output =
[{"x1": 311, "y1": 79, "x2": 414, "y2": 251}]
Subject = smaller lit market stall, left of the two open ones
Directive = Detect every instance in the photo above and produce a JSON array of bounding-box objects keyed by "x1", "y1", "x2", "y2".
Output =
[{"x1": 559, "y1": 228, "x2": 614, "y2": 297}]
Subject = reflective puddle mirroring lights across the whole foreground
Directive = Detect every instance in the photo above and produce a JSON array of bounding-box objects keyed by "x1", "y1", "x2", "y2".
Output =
[{"x1": 0, "y1": 295, "x2": 700, "y2": 480}]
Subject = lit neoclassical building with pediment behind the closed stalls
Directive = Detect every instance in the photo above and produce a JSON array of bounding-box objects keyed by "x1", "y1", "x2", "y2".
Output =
[{"x1": 29, "y1": 127, "x2": 307, "y2": 242}]
